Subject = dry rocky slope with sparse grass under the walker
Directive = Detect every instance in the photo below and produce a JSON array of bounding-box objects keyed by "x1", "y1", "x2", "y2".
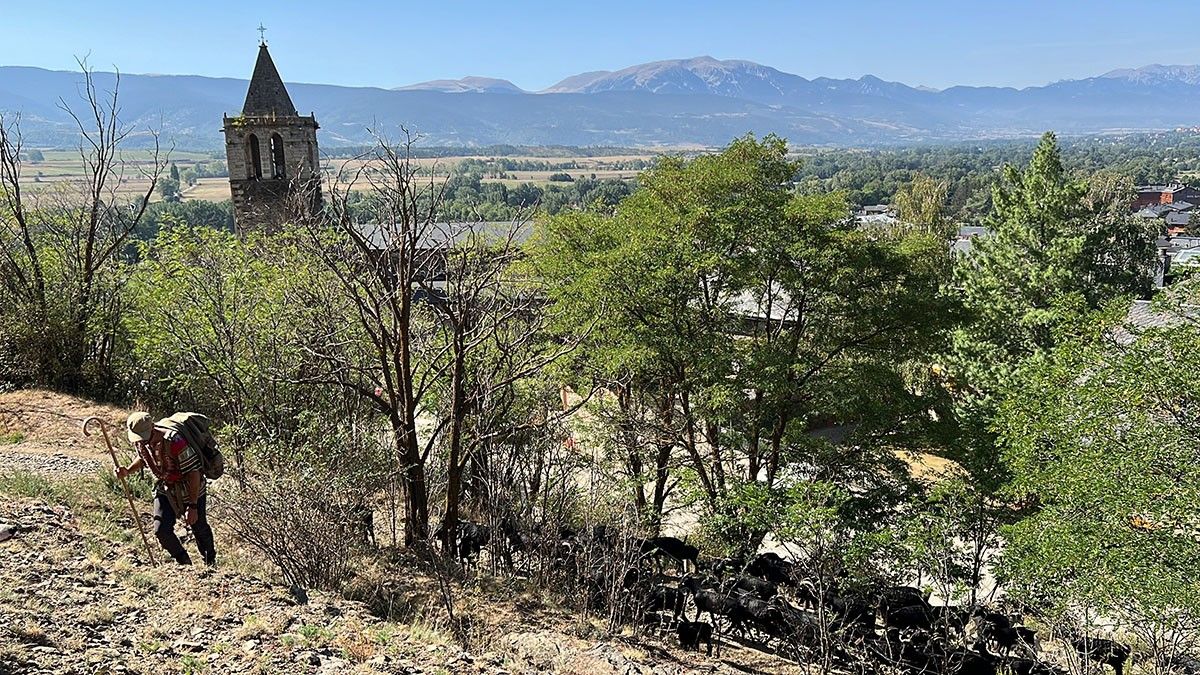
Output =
[{"x1": 0, "y1": 392, "x2": 803, "y2": 675}]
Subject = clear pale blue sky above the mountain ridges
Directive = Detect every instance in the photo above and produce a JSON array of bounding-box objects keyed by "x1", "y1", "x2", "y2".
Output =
[{"x1": 0, "y1": 0, "x2": 1200, "y2": 90}]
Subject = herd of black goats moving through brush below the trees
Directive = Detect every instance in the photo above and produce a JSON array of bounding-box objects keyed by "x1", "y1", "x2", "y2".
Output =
[{"x1": 438, "y1": 521, "x2": 1166, "y2": 675}]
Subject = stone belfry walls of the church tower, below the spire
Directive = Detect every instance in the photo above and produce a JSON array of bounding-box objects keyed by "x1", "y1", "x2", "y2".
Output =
[{"x1": 224, "y1": 115, "x2": 320, "y2": 234}]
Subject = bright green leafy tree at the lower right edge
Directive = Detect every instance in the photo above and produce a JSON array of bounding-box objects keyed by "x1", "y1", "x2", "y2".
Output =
[{"x1": 998, "y1": 295, "x2": 1200, "y2": 671}]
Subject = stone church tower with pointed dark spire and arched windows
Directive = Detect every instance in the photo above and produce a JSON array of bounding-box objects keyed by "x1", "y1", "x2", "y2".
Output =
[{"x1": 224, "y1": 41, "x2": 320, "y2": 235}]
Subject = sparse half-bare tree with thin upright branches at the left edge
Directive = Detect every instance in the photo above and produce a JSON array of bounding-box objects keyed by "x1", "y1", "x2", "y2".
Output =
[{"x1": 0, "y1": 64, "x2": 166, "y2": 392}]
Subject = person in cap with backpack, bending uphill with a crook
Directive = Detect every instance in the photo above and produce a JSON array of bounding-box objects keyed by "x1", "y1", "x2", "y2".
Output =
[{"x1": 116, "y1": 412, "x2": 217, "y2": 567}]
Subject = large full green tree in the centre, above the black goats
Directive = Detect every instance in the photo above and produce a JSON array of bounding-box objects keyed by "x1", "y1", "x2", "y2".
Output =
[{"x1": 536, "y1": 137, "x2": 949, "y2": 546}]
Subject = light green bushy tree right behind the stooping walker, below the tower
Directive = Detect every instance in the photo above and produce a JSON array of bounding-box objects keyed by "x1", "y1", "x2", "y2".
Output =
[{"x1": 125, "y1": 225, "x2": 349, "y2": 456}]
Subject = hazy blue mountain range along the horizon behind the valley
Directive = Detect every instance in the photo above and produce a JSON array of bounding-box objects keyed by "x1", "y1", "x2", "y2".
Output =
[{"x1": 0, "y1": 56, "x2": 1200, "y2": 149}]
